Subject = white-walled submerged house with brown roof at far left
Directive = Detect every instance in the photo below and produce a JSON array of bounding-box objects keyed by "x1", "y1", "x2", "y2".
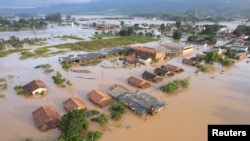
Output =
[{"x1": 22, "y1": 80, "x2": 47, "y2": 96}]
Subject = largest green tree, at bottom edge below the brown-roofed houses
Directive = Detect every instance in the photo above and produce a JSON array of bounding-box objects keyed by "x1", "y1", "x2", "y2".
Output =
[{"x1": 58, "y1": 110, "x2": 89, "y2": 141}]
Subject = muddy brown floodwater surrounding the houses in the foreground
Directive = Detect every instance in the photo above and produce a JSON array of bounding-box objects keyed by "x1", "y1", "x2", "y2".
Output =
[{"x1": 0, "y1": 50, "x2": 250, "y2": 141}]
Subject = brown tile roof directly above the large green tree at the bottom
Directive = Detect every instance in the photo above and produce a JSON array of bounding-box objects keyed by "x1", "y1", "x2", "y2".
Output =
[{"x1": 63, "y1": 97, "x2": 87, "y2": 111}]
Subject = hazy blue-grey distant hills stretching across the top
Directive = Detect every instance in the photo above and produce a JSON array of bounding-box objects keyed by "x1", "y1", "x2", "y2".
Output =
[{"x1": 0, "y1": 0, "x2": 250, "y2": 17}]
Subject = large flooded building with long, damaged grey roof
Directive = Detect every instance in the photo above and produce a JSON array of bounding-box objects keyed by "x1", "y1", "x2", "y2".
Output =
[{"x1": 108, "y1": 85, "x2": 166, "y2": 116}]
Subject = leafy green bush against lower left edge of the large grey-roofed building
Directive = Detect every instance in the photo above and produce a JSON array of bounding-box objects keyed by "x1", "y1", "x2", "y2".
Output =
[{"x1": 109, "y1": 102, "x2": 126, "y2": 120}]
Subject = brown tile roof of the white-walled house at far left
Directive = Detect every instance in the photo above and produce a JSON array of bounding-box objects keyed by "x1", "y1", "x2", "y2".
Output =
[{"x1": 22, "y1": 80, "x2": 46, "y2": 95}]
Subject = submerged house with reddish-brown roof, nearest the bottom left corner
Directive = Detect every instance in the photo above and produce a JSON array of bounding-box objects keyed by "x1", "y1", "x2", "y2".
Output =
[{"x1": 32, "y1": 106, "x2": 59, "y2": 131}]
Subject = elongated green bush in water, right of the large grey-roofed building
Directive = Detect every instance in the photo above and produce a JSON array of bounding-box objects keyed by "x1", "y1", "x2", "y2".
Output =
[{"x1": 160, "y1": 77, "x2": 189, "y2": 93}]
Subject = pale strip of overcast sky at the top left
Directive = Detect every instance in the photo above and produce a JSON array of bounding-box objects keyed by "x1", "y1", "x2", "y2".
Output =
[{"x1": 0, "y1": 0, "x2": 93, "y2": 7}]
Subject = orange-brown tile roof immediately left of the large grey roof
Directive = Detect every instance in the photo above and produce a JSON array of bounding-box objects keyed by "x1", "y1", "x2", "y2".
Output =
[{"x1": 87, "y1": 90, "x2": 114, "y2": 107}]
